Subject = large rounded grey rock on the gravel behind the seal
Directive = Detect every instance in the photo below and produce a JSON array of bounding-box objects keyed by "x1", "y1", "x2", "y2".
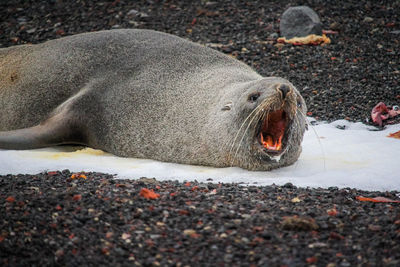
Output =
[{"x1": 279, "y1": 6, "x2": 322, "y2": 39}]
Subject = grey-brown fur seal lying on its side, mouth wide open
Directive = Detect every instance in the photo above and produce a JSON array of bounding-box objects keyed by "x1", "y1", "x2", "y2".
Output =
[{"x1": 0, "y1": 29, "x2": 306, "y2": 170}]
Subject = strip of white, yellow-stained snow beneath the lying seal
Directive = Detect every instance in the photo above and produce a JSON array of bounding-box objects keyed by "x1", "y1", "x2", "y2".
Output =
[{"x1": 0, "y1": 120, "x2": 400, "y2": 191}]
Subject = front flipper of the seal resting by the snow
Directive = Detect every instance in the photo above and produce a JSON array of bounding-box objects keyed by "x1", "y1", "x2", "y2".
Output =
[{"x1": 0, "y1": 114, "x2": 85, "y2": 149}]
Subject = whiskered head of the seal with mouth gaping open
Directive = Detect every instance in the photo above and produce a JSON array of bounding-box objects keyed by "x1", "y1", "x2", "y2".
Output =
[{"x1": 225, "y1": 77, "x2": 307, "y2": 170}]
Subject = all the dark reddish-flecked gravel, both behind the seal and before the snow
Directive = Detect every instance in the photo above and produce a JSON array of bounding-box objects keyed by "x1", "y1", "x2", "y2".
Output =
[{"x1": 0, "y1": 0, "x2": 400, "y2": 267}]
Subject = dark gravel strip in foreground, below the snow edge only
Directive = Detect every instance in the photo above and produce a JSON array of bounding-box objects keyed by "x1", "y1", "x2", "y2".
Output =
[{"x1": 0, "y1": 171, "x2": 400, "y2": 267}]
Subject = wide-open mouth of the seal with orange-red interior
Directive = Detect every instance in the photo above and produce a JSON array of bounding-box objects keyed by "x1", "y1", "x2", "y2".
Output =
[{"x1": 258, "y1": 109, "x2": 287, "y2": 155}]
